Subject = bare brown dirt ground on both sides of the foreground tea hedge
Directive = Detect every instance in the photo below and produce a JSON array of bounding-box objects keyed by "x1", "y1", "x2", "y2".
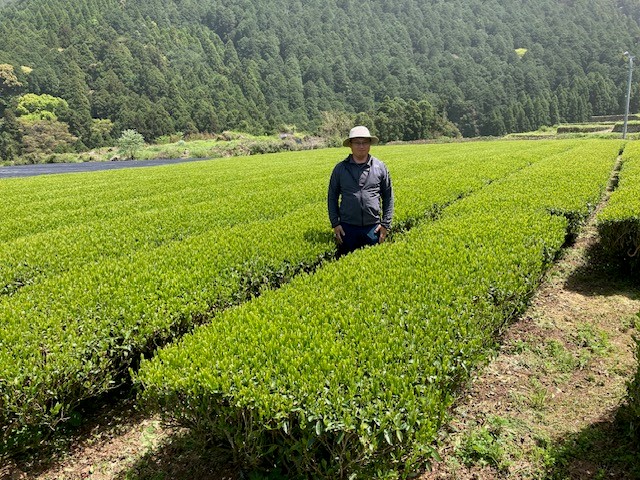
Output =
[{"x1": 6, "y1": 178, "x2": 640, "y2": 480}]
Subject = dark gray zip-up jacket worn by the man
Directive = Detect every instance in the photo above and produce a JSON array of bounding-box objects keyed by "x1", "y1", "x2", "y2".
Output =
[{"x1": 327, "y1": 155, "x2": 393, "y2": 229}]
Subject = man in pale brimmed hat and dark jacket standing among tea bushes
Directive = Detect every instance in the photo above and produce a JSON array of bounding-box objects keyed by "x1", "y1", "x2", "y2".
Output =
[{"x1": 327, "y1": 126, "x2": 393, "y2": 256}]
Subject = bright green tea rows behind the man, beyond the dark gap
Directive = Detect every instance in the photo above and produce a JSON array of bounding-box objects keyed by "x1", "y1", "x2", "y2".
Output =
[{"x1": 0, "y1": 142, "x2": 578, "y2": 454}]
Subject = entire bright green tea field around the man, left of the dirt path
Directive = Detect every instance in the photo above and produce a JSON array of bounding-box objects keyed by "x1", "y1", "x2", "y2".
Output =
[{"x1": 0, "y1": 140, "x2": 622, "y2": 476}]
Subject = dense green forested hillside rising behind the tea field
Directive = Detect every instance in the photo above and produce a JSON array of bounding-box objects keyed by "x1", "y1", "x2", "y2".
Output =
[{"x1": 0, "y1": 0, "x2": 640, "y2": 159}]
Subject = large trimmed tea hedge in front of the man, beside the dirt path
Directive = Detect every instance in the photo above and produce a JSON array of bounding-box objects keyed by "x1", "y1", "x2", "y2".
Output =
[{"x1": 136, "y1": 142, "x2": 620, "y2": 478}]
